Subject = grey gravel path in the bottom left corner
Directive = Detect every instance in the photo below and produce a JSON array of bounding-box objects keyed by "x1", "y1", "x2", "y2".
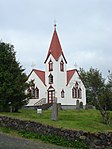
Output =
[{"x1": 0, "y1": 133, "x2": 70, "y2": 149}]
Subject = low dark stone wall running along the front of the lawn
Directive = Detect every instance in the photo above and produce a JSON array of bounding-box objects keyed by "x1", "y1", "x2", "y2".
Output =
[{"x1": 0, "y1": 116, "x2": 112, "y2": 149}]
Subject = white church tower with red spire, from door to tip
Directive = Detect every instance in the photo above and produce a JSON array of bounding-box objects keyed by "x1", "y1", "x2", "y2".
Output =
[{"x1": 44, "y1": 25, "x2": 67, "y2": 103}]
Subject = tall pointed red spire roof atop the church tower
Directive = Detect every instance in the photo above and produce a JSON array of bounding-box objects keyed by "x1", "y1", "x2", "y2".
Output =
[{"x1": 45, "y1": 29, "x2": 67, "y2": 63}]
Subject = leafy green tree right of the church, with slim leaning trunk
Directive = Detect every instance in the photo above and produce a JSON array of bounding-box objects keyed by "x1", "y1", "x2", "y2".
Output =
[{"x1": 80, "y1": 68, "x2": 112, "y2": 124}]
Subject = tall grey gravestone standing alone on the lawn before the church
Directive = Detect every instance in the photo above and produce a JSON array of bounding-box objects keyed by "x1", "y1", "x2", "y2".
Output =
[{"x1": 51, "y1": 99, "x2": 58, "y2": 121}]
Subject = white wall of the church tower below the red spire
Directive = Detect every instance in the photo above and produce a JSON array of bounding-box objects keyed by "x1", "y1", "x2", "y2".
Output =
[{"x1": 45, "y1": 55, "x2": 67, "y2": 102}]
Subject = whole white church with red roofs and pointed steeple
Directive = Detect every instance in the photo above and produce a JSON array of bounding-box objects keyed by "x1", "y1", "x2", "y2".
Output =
[{"x1": 27, "y1": 25, "x2": 86, "y2": 109}]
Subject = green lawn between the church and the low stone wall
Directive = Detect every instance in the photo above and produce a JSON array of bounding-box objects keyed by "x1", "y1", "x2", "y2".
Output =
[{"x1": 0, "y1": 109, "x2": 112, "y2": 132}]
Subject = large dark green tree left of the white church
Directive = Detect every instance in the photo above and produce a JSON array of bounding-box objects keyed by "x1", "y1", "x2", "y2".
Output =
[{"x1": 0, "y1": 42, "x2": 28, "y2": 112}]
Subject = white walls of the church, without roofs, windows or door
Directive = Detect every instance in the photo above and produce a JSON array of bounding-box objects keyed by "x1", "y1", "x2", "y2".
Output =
[{"x1": 28, "y1": 55, "x2": 86, "y2": 105}]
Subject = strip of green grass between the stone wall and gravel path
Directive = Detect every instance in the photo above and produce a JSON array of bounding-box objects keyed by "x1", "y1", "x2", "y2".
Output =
[{"x1": 0, "y1": 127, "x2": 89, "y2": 149}]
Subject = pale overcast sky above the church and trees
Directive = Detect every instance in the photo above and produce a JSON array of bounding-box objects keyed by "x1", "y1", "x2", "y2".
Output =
[{"x1": 0, "y1": 0, "x2": 112, "y2": 76}]
